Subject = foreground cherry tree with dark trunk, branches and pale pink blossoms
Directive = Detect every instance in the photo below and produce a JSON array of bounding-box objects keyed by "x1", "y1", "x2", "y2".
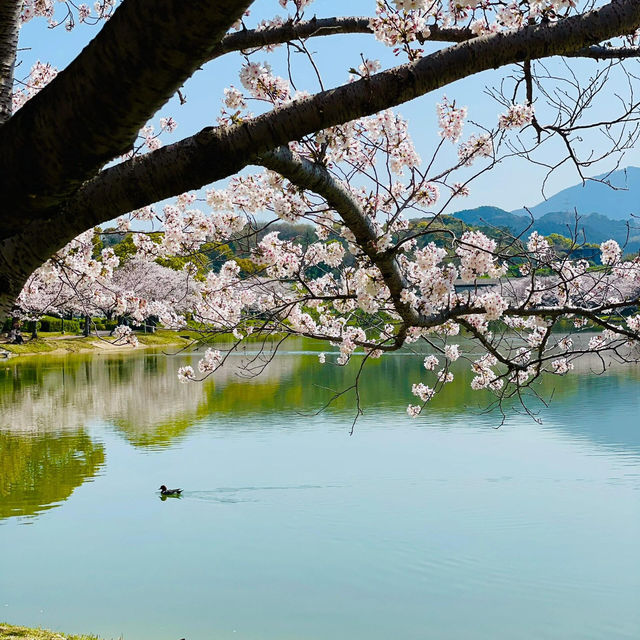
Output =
[{"x1": 0, "y1": 0, "x2": 640, "y2": 416}]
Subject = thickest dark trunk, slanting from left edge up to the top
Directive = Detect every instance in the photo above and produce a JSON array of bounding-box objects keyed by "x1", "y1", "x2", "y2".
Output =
[{"x1": 0, "y1": 0, "x2": 251, "y2": 237}]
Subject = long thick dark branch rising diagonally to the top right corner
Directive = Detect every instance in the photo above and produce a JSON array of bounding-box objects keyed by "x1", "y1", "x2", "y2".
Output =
[{"x1": 65, "y1": 0, "x2": 640, "y2": 238}]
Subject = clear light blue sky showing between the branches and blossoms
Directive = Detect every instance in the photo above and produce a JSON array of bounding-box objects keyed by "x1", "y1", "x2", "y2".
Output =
[{"x1": 17, "y1": 0, "x2": 640, "y2": 215}]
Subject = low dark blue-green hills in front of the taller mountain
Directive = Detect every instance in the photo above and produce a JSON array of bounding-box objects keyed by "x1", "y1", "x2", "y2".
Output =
[{"x1": 452, "y1": 207, "x2": 640, "y2": 253}]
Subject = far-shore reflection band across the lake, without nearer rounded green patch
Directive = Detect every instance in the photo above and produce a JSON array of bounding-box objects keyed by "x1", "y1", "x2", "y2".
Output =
[{"x1": 0, "y1": 342, "x2": 640, "y2": 451}]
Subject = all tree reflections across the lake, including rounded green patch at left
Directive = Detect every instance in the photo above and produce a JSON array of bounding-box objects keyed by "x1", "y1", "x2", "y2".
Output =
[{"x1": 0, "y1": 343, "x2": 640, "y2": 518}]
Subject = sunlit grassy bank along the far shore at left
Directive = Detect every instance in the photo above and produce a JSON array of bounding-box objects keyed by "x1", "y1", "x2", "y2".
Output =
[{"x1": 0, "y1": 330, "x2": 199, "y2": 360}]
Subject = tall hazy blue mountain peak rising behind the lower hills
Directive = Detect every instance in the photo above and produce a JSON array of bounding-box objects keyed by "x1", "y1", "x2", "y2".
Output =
[{"x1": 512, "y1": 167, "x2": 640, "y2": 220}]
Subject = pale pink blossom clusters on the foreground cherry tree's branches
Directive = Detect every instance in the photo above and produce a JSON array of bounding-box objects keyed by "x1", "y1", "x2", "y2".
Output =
[{"x1": 8, "y1": 0, "x2": 640, "y2": 417}]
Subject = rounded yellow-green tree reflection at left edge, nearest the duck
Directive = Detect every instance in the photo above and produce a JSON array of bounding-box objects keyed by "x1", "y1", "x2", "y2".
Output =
[{"x1": 0, "y1": 430, "x2": 105, "y2": 520}]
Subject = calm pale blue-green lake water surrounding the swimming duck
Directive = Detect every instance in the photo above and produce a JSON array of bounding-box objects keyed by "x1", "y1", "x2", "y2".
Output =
[{"x1": 0, "y1": 345, "x2": 640, "y2": 640}]
